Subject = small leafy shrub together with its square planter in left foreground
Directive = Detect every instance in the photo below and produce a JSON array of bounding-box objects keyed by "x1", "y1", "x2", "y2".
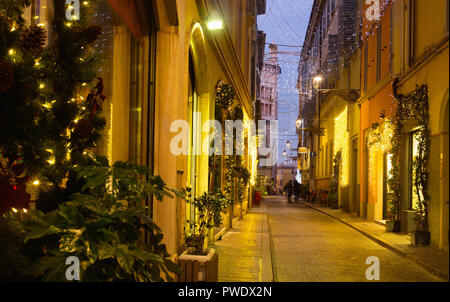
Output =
[{"x1": 179, "y1": 192, "x2": 232, "y2": 282}]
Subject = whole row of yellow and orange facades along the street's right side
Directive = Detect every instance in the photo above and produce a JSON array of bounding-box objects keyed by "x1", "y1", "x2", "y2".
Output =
[{"x1": 299, "y1": 0, "x2": 449, "y2": 249}]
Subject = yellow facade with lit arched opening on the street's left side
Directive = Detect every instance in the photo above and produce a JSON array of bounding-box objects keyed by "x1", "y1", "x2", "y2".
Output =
[{"x1": 25, "y1": 0, "x2": 265, "y2": 256}]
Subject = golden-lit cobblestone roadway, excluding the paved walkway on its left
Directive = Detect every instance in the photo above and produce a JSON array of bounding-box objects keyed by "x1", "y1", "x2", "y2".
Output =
[{"x1": 265, "y1": 197, "x2": 442, "y2": 282}]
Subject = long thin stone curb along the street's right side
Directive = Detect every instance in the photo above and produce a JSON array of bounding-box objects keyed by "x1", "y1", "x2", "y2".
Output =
[{"x1": 305, "y1": 202, "x2": 449, "y2": 282}]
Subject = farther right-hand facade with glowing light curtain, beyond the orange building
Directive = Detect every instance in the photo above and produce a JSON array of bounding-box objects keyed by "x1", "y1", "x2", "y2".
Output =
[{"x1": 299, "y1": 0, "x2": 361, "y2": 213}]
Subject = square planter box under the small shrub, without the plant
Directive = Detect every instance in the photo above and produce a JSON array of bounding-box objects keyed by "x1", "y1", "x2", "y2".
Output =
[{"x1": 179, "y1": 248, "x2": 219, "y2": 282}]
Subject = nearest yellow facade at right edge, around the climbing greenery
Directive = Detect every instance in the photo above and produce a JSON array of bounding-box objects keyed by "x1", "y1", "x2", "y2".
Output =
[{"x1": 393, "y1": 0, "x2": 449, "y2": 249}]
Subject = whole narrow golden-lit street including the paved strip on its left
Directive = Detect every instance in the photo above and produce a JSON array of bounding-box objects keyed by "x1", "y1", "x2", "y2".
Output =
[{"x1": 216, "y1": 196, "x2": 442, "y2": 282}]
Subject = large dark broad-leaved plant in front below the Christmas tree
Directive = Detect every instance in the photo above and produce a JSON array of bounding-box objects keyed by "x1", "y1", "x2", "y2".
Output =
[{"x1": 11, "y1": 157, "x2": 179, "y2": 281}]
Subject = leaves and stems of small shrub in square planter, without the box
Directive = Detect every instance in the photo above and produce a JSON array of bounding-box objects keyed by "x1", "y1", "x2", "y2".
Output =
[{"x1": 186, "y1": 191, "x2": 232, "y2": 255}]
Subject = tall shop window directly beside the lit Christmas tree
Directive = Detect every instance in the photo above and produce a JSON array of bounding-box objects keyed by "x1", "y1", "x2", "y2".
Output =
[{"x1": 92, "y1": 0, "x2": 148, "y2": 164}]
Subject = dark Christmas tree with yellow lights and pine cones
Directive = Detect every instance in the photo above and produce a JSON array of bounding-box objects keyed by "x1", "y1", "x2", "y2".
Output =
[{"x1": 0, "y1": 0, "x2": 105, "y2": 213}]
